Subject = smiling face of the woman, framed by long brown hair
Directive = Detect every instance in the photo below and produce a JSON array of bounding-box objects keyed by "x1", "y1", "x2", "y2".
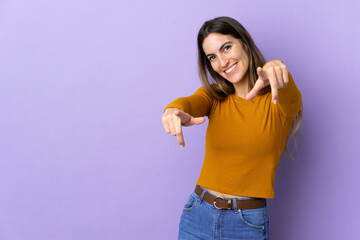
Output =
[{"x1": 202, "y1": 33, "x2": 249, "y2": 84}]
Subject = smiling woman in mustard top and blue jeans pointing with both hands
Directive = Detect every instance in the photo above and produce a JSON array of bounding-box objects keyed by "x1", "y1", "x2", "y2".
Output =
[{"x1": 162, "y1": 17, "x2": 302, "y2": 240}]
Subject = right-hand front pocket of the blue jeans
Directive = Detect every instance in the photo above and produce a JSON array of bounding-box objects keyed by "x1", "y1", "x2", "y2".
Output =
[{"x1": 239, "y1": 207, "x2": 266, "y2": 229}]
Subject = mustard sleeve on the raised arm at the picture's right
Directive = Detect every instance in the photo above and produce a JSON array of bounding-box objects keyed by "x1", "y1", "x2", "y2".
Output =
[{"x1": 278, "y1": 72, "x2": 302, "y2": 118}]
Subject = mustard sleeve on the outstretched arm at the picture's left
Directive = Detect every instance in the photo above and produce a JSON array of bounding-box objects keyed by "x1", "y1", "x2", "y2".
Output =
[{"x1": 164, "y1": 87, "x2": 213, "y2": 117}]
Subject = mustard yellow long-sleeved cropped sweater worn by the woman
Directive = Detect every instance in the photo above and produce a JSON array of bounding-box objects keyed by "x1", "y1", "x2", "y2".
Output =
[{"x1": 164, "y1": 65, "x2": 302, "y2": 198}]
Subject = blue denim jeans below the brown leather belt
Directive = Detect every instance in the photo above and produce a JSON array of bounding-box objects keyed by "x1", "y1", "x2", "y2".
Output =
[{"x1": 178, "y1": 187, "x2": 269, "y2": 240}]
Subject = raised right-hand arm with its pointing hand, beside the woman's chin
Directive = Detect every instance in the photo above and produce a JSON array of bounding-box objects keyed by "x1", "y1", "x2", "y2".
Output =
[{"x1": 246, "y1": 59, "x2": 302, "y2": 117}]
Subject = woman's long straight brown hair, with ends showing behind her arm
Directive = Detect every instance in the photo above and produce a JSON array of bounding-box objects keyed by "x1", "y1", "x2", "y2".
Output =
[{"x1": 197, "y1": 17, "x2": 303, "y2": 159}]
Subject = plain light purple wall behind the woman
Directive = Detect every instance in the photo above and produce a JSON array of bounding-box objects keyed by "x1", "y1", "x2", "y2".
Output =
[{"x1": 0, "y1": 0, "x2": 360, "y2": 240}]
